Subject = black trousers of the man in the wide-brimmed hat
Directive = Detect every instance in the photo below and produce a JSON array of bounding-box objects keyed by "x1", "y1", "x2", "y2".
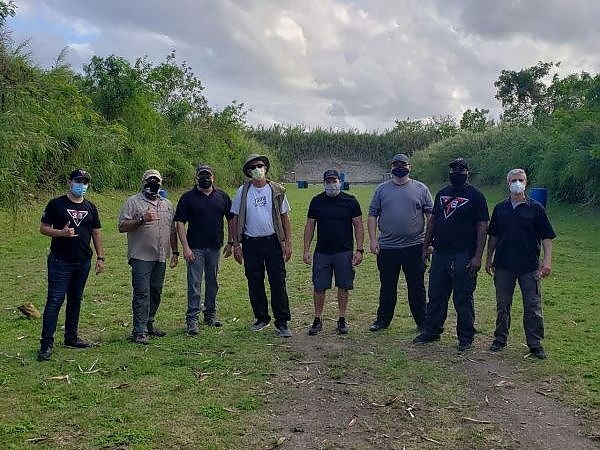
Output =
[{"x1": 242, "y1": 234, "x2": 291, "y2": 325}]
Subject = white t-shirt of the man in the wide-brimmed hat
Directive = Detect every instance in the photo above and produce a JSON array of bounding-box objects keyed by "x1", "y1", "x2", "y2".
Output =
[{"x1": 231, "y1": 183, "x2": 290, "y2": 237}]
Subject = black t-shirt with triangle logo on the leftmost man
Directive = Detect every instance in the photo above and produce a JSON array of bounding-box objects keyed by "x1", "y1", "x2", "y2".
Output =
[{"x1": 42, "y1": 195, "x2": 100, "y2": 261}]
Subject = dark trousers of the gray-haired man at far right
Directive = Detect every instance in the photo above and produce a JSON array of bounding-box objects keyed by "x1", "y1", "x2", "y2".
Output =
[{"x1": 494, "y1": 269, "x2": 544, "y2": 348}]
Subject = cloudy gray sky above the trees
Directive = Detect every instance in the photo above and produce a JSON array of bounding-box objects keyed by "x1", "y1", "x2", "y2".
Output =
[{"x1": 8, "y1": 0, "x2": 600, "y2": 131}]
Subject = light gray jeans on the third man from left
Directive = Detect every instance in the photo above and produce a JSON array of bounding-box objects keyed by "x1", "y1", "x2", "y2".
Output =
[{"x1": 185, "y1": 248, "x2": 220, "y2": 323}]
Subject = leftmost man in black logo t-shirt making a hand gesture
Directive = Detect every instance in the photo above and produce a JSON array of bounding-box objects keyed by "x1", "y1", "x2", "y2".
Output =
[{"x1": 37, "y1": 169, "x2": 104, "y2": 361}]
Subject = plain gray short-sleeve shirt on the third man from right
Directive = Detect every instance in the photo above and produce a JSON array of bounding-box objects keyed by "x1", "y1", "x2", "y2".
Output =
[{"x1": 369, "y1": 180, "x2": 433, "y2": 249}]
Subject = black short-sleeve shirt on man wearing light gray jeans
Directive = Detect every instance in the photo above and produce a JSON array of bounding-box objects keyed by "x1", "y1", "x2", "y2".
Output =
[{"x1": 175, "y1": 187, "x2": 233, "y2": 249}]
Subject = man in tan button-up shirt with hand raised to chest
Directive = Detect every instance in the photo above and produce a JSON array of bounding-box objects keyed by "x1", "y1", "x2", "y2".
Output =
[{"x1": 119, "y1": 170, "x2": 179, "y2": 344}]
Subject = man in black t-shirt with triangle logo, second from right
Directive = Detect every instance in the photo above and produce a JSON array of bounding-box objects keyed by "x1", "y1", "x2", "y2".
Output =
[{"x1": 413, "y1": 158, "x2": 489, "y2": 352}]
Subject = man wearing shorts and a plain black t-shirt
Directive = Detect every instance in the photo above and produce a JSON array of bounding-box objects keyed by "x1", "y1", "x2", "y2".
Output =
[{"x1": 303, "y1": 170, "x2": 364, "y2": 336}]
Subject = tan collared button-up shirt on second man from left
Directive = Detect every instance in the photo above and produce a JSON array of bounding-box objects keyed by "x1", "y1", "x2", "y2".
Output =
[{"x1": 119, "y1": 192, "x2": 175, "y2": 262}]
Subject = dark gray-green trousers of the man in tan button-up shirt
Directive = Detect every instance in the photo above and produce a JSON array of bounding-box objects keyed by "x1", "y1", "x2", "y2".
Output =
[{"x1": 129, "y1": 258, "x2": 166, "y2": 336}]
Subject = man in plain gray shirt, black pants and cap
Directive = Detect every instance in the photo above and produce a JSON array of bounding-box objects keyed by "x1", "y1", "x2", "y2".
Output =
[{"x1": 367, "y1": 153, "x2": 433, "y2": 331}]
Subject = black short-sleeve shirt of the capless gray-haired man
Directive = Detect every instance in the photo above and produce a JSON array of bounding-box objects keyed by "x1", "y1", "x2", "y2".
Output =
[{"x1": 488, "y1": 198, "x2": 556, "y2": 274}]
